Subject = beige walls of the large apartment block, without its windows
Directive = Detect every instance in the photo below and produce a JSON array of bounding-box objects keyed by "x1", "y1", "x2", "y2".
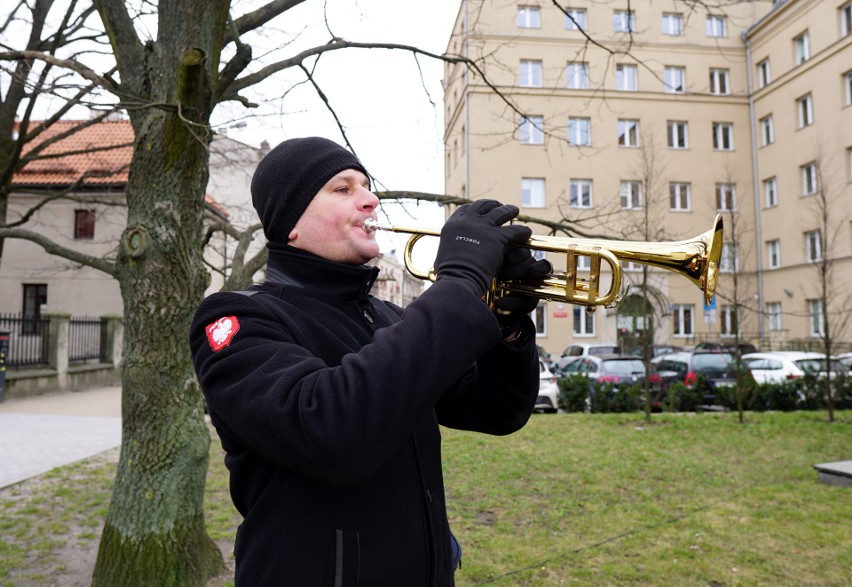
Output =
[{"x1": 444, "y1": 0, "x2": 852, "y2": 353}]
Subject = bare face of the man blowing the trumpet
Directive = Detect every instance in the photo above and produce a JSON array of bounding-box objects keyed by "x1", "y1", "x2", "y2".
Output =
[{"x1": 289, "y1": 169, "x2": 379, "y2": 265}]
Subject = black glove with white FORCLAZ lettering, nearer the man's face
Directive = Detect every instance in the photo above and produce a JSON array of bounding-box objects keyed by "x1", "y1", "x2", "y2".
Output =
[{"x1": 435, "y1": 200, "x2": 532, "y2": 296}]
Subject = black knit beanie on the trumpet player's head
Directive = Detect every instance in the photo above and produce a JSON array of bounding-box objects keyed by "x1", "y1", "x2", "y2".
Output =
[{"x1": 251, "y1": 137, "x2": 369, "y2": 244}]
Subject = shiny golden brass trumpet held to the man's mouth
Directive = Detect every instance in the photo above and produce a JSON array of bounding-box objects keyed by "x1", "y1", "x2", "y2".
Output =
[{"x1": 363, "y1": 215, "x2": 722, "y2": 311}]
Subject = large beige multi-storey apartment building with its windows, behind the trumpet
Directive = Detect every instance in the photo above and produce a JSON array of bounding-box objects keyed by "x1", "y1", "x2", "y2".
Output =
[{"x1": 444, "y1": 0, "x2": 852, "y2": 354}]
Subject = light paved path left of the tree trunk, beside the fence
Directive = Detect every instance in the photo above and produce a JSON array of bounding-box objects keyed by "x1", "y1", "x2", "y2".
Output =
[{"x1": 0, "y1": 387, "x2": 121, "y2": 487}]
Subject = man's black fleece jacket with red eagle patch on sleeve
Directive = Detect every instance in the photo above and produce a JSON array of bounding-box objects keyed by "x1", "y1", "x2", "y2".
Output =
[{"x1": 190, "y1": 248, "x2": 538, "y2": 586}]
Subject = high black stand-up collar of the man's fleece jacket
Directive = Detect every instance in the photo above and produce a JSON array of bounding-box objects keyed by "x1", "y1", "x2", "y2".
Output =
[{"x1": 266, "y1": 243, "x2": 379, "y2": 300}]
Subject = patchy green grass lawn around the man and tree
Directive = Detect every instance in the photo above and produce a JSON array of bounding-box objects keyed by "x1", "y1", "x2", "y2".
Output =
[{"x1": 0, "y1": 411, "x2": 852, "y2": 586}]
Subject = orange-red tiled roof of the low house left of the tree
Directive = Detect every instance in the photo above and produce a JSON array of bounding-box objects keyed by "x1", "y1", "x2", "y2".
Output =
[{"x1": 12, "y1": 120, "x2": 133, "y2": 187}]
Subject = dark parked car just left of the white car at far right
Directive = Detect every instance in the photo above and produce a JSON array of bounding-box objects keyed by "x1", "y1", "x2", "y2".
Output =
[{"x1": 648, "y1": 351, "x2": 737, "y2": 406}]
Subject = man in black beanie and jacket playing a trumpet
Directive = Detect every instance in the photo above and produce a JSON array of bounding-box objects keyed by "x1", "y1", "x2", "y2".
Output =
[{"x1": 190, "y1": 137, "x2": 550, "y2": 586}]
